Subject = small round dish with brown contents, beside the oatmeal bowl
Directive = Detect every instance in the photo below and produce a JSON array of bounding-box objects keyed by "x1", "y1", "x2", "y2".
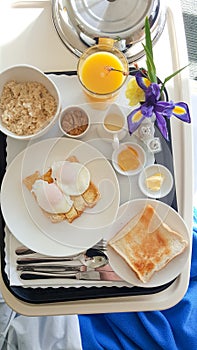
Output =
[{"x1": 59, "y1": 106, "x2": 90, "y2": 138}]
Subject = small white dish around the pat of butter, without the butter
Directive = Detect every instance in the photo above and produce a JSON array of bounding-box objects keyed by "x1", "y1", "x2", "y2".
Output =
[{"x1": 138, "y1": 164, "x2": 173, "y2": 199}]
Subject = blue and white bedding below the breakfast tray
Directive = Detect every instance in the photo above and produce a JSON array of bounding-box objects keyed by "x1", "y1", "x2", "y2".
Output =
[{"x1": 0, "y1": 208, "x2": 197, "y2": 350}]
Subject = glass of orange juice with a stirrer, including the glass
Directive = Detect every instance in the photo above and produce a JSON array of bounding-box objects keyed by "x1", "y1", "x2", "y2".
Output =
[{"x1": 77, "y1": 38, "x2": 129, "y2": 108}]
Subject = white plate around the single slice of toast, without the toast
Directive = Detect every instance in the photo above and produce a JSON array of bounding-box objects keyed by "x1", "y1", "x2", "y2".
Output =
[{"x1": 105, "y1": 199, "x2": 190, "y2": 288}]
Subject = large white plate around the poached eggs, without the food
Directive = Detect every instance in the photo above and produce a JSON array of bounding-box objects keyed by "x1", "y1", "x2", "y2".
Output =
[{"x1": 1, "y1": 138, "x2": 120, "y2": 255}]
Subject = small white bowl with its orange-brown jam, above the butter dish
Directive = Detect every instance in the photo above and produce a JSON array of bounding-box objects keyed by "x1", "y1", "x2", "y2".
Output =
[{"x1": 112, "y1": 142, "x2": 146, "y2": 176}]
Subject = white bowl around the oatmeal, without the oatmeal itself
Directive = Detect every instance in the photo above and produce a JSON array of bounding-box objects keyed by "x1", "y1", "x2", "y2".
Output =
[{"x1": 0, "y1": 64, "x2": 61, "y2": 140}]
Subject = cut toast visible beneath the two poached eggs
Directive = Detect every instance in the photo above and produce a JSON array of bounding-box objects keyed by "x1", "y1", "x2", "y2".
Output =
[{"x1": 23, "y1": 156, "x2": 100, "y2": 223}]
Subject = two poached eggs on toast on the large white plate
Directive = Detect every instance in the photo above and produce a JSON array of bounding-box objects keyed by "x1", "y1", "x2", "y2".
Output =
[{"x1": 23, "y1": 156, "x2": 100, "y2": 223}]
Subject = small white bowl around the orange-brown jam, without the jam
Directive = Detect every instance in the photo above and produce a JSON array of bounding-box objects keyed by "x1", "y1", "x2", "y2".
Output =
[{"x1": 112, "y1": 142, "x2": 146, "y2": 176}]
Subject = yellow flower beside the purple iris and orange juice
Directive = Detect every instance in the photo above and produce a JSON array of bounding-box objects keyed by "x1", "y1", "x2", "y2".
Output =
[{"x1": 125, "y1": 77, "x2": 150, "y2": 106}]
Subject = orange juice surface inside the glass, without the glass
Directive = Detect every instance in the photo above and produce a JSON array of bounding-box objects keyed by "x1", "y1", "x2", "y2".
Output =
[{"x1": 81, "y1": 51, "x2": 125, "y2": 94}]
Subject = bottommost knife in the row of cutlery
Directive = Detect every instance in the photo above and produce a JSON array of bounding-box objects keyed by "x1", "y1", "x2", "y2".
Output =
[{"x1": 20, "y1": 271, "x2": 101, "y2": 281}]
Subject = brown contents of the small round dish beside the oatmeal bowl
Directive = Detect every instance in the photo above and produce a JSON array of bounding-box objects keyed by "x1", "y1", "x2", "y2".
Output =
[{"x1": 61, "y1": 107, "x2": 89, "y2": 136}]
